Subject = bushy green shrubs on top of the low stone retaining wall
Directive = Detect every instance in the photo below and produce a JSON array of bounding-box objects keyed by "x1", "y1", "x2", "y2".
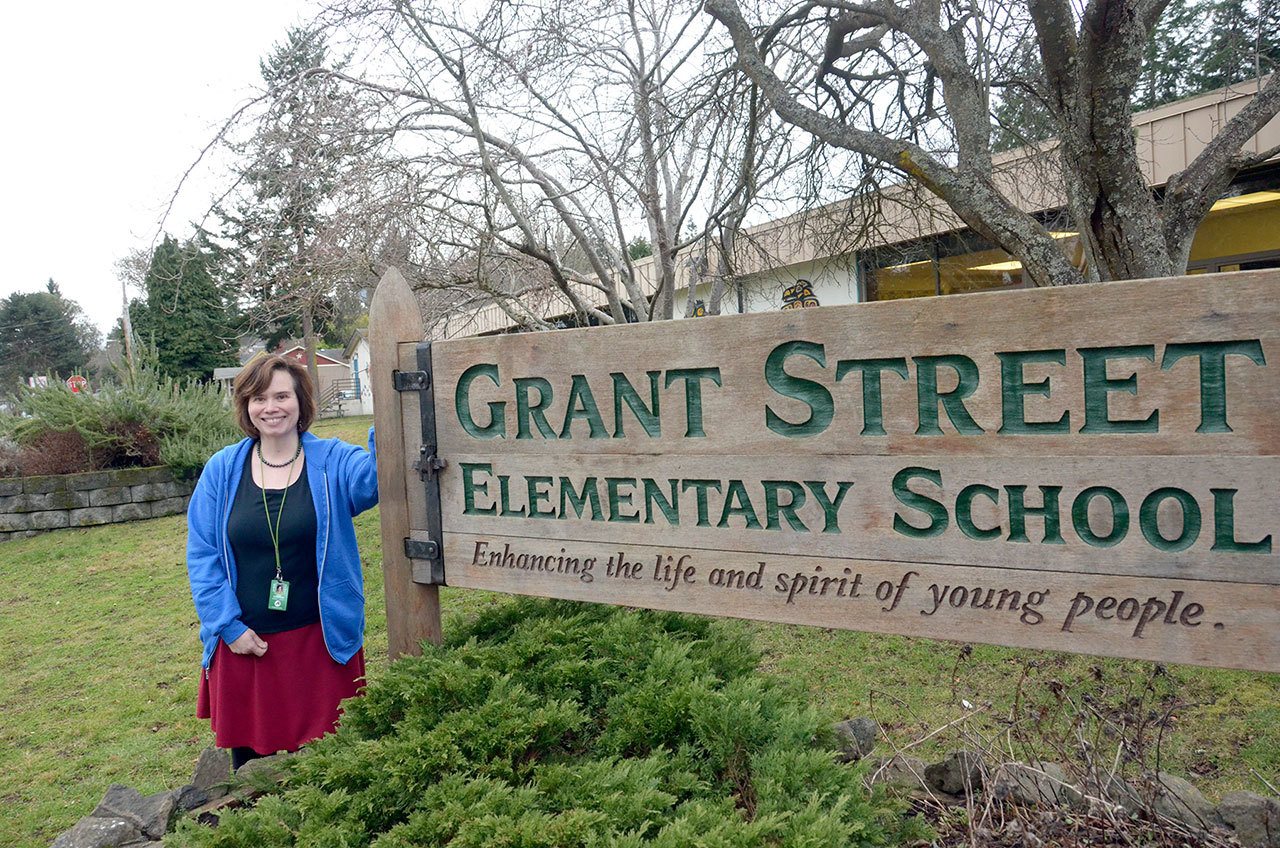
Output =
[{"x1": 0, "y1": 366, "x2": 239, "y2": 478}]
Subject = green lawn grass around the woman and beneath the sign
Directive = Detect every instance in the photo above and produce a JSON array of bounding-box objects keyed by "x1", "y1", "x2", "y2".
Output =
[{"x1": 0, "y1": 418, "x2": 1280, "y2": 848}]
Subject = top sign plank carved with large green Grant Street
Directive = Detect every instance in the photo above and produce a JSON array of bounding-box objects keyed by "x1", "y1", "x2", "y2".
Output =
[{"x1": 435, "y1": 272, "x2": 1280, "y2": 456}]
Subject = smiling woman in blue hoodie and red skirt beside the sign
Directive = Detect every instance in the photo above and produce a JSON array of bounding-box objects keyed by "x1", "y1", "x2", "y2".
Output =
[{"x1": 187, "y1": 356, "x2": 378, "y2": 769}]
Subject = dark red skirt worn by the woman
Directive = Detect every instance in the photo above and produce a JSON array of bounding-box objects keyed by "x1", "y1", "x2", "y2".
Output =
[{"x1": 196, "y1": 621, "x2": 365, "y2": 754}]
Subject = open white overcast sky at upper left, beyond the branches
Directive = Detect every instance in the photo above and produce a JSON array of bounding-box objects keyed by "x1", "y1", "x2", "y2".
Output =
[{"x1": 0, "y1": 0, "x2": 316, "y2": 333}]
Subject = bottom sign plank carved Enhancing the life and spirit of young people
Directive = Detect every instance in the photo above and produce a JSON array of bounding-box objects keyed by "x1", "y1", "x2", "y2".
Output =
[{"x1": 444, "y1": 533, "x2": 1280, "y2": 671}]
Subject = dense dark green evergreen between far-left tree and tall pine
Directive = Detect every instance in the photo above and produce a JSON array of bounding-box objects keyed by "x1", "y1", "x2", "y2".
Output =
[{"x1": 129, "y1": 236, "x2": 236, "y2": 380}]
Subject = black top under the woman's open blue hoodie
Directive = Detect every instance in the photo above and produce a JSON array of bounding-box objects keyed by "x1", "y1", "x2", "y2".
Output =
[{"x1": 227, "y1": 451, "x2": 320, "y2": 634}]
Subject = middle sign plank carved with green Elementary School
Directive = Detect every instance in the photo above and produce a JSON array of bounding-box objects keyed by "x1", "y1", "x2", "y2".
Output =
[{"x1": 413, "y1": 453, "x2": 1280, "y2": 584}]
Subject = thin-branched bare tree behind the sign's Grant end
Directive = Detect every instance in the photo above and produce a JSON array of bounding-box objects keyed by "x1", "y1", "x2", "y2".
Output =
[{"x1": 307, "y1": 0, "x2": 786, "y2": 328}]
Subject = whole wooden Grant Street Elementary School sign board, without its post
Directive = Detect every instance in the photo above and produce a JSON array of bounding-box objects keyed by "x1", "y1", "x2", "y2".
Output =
[{"x1": 389, "y1": 272, "x2": 1280, "y2": 671}]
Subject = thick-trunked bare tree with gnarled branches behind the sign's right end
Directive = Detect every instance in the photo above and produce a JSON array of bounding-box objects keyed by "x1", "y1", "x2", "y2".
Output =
[{"x1": 705, "y1": 0, "x2": 1280, "y2": 286}]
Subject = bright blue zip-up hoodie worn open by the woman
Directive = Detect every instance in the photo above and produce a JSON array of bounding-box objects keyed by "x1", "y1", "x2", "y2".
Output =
[{"x1": 187, "y1": 428, "x2": 378, "y2": 669}]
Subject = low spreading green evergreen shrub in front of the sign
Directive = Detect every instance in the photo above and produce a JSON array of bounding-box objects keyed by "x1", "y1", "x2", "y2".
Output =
[{"x1": 166, "y1": 599, "x2": 923, "y2": 848}]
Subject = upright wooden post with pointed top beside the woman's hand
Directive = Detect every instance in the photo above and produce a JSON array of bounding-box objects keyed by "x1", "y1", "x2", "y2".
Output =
[{"x1": 369, "y1": 268, "x2": 442, "y2": 658}]
